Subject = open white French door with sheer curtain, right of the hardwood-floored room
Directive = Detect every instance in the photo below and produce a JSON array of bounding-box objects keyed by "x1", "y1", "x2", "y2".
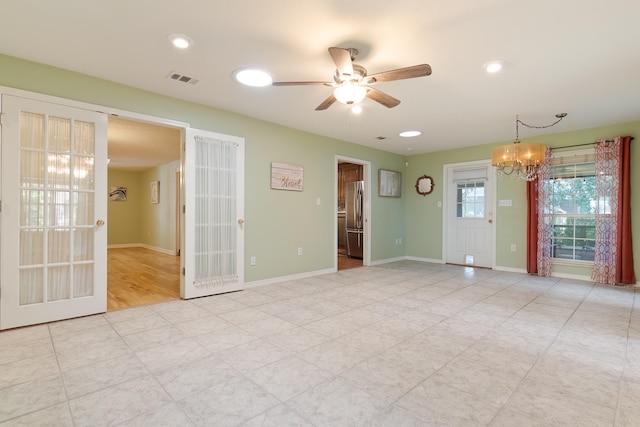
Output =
[{"x1": 180, "y1": 128, "x2": 244, "y2": 299}]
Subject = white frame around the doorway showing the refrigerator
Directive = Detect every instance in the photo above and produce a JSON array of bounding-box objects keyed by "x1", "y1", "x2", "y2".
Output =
[{"x1": 333, "y1": 155, "x2": 371, "y2": 271}]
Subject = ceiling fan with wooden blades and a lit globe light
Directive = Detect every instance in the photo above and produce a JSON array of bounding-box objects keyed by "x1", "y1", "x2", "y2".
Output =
[{"x1": 272, "y1": 47, "x2": 431, "y2": 111}]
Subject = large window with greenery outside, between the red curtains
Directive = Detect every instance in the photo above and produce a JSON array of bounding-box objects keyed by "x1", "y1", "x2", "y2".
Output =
[{"x1": 547, "y1": 157, "x2": 596, "y2": 261}]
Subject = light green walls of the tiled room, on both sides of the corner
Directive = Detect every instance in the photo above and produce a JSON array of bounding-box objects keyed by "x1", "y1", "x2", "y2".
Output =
[{"x1": 0, "y1": 55, "x2": 640, "y2": 282}]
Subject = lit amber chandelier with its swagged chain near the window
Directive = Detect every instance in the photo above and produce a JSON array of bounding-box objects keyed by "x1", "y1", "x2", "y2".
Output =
[{"x1": 491, "y1": 113, "x2": 567, "y2": 181}]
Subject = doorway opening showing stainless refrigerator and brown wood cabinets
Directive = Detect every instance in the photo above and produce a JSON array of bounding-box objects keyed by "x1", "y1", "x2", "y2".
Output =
[{"x1": 335, "y1": 156, "x2": 371, "y2": 271}]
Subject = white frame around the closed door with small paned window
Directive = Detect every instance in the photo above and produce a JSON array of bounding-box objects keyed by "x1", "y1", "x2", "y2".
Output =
[{"x1": 442, "y1": 160, "x2": 498, "y2": 270}]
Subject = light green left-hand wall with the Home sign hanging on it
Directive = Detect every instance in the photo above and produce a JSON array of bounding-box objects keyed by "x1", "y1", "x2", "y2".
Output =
[{"x1": 0, "y1": 55, "x2": 405, "y2": 282}]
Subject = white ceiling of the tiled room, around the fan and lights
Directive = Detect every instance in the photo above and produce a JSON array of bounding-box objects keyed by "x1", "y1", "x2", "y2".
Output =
[{"x1": 0, "y1": 0, "x2": 640, "y2": 155}]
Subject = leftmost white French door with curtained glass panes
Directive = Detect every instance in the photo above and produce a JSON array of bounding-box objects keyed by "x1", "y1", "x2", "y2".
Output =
[{"x1": 0, "y1": 95, "x2": 107, "y2": 329}]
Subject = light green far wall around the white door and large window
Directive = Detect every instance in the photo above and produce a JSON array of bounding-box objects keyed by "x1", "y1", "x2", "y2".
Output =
[{"x1": 404, "y1": 122, "x2": 640, "y2": 276}]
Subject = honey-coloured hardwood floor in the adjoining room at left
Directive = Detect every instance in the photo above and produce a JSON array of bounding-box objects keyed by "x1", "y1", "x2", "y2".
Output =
[{"x1": 107, "y1": 248, "x2": 180, "y2": 311}]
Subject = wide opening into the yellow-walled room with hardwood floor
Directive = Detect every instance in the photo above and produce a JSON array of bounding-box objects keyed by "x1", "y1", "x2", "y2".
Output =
[{"x1": 107, "y1": 116, "x2": 181, "y2": 311}]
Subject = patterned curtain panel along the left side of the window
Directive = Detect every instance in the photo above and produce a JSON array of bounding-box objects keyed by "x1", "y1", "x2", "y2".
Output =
[{"x1": 537, "y1": 147, "x2": 553, "y2": 277}]
